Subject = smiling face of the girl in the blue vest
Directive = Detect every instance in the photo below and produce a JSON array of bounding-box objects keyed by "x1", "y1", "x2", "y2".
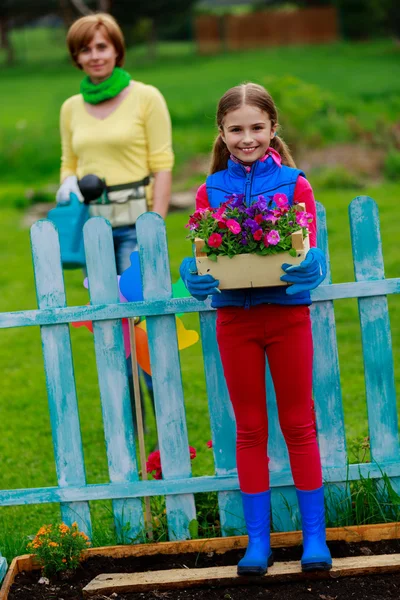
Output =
[{"x1": 220, "y1": 104, "x2": 276, "y2": 163}]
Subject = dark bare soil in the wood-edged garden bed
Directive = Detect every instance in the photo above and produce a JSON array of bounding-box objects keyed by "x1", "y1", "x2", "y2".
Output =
[{"x1": 8, "y1": 540, "x2": 400, "y2": 600}]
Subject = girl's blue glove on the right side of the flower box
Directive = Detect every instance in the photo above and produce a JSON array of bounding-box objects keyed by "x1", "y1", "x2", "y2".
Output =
[{"x1": 281, "y1": 248, "x2": 326, "y2": 296}]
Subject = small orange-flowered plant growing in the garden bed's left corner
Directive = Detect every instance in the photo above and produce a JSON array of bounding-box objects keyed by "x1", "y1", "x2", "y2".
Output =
[{"x1": 28, "y1": 523, "x2": 90, "y2": 577}]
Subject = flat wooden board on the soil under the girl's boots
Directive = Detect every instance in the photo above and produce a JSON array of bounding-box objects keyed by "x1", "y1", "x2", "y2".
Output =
[{"x1": 82, "y1": 554, "x2": 400, "y2": 598}]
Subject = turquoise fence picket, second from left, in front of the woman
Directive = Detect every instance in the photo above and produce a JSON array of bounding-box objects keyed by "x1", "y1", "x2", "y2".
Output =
[{"x1": 83, "y1": 217, "x2": 144, "y2": 542}]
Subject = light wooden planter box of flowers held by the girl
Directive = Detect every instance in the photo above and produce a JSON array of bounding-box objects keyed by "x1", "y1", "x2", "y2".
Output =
[{"x1": 195, "y1": 231, "x2": 310, "y2": 290}]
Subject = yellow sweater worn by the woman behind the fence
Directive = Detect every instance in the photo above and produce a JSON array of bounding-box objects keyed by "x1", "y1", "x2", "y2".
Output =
[{"x1": 60, "y1": 81, "x2": 174, "y2": 218}]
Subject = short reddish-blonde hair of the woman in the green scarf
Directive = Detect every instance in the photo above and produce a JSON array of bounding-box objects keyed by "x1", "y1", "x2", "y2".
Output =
[{"x1": 67, "y1": 13, "x2": 125, "y2": 69}]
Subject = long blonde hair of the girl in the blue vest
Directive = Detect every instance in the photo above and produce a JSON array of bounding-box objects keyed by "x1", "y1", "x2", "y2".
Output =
[{"x1": 210, "y1": 83, "x2": 296, "y2": 173}]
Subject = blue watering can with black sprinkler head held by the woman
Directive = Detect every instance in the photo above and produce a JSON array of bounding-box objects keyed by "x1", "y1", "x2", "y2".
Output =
[{"x1": 47, "y1": 175, "x2": 105, "y2": 269}]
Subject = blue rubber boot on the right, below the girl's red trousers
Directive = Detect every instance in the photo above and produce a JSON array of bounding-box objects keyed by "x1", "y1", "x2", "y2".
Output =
[{"x1": 296, "y1": 487, "x2": 332, "y2": 572}]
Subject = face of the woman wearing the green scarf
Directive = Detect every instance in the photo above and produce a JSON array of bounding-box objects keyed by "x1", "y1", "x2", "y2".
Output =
[{"x1": 77, "y1": 29, "x2": 118, "y2": 83}]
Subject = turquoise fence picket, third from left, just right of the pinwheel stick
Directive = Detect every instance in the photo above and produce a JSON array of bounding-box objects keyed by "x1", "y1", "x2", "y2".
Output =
[{"x1": 136, "y1": 213, "x2": 196, "y2": 540}]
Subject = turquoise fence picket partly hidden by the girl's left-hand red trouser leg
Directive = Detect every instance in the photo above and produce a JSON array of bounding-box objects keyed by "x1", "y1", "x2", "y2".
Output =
[{"x1": 200, "y1": 312, "x2": 246, "y2": 536}]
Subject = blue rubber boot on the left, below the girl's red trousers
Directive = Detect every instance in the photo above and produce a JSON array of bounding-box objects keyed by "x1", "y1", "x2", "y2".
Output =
[{"x1": 237, "y1": 490, "x2": 274, "y2": 575}]
